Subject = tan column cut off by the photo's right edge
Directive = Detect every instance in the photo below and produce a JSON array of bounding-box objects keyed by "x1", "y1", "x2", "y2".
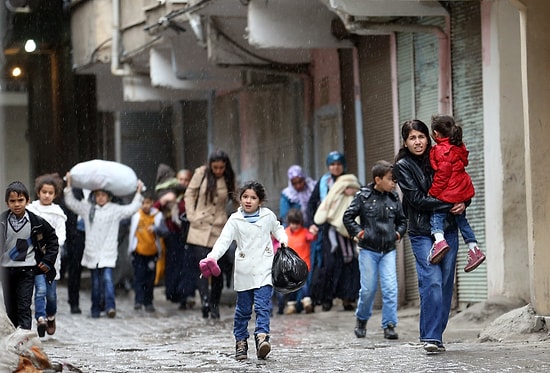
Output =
[{"x1": 524, "y1": 0, "x2": 550, "y2": 315}]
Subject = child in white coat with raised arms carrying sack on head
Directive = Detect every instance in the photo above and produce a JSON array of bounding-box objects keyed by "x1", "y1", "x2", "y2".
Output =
[{"x1": 64, "y1": 172, "x2": 143, "y2": 318}]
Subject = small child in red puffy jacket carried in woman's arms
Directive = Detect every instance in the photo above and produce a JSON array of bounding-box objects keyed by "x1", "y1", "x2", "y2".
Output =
[{"x1": 429, "y1": 115, "x2": 485, "y2": 272}]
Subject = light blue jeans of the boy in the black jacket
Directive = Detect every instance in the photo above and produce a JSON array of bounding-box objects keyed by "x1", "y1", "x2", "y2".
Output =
[{"x1": 355, "y1": 249, "x2": 398, "y2": 329}]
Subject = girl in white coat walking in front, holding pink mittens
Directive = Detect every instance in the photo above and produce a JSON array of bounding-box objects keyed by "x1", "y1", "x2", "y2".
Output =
[{"x1": 200, "y1": 181, "x2": 288, "y2": 360}]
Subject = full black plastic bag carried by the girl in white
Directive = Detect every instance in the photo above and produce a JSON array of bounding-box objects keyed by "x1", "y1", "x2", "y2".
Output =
[{"x1": 271, "y1": 245, "x2": 309, "y2": 294}]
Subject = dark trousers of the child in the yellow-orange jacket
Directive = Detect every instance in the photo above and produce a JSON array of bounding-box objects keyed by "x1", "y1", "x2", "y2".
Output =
[{"x1": 132, "y1": 254, "x2": 157, "y2": 306}]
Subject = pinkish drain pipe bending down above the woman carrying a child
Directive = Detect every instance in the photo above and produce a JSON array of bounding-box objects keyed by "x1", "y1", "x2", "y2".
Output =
[{"x1": 346, "y1": 20, "x2": 452, "y2": 114}]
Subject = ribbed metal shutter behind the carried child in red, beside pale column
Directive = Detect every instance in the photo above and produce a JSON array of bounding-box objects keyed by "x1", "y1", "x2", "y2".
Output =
[{"x1": 450, "y1": 2, "x2": 487, "y2": 305}]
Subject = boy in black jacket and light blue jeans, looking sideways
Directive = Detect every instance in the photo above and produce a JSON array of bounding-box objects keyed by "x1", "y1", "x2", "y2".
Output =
[{"x1": 343, "y1": 161, "x2": 407, "y2": 339}]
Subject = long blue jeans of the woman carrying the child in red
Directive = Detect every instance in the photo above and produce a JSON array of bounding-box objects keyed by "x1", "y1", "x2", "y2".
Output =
[{"x1": 409, "y1": 230, "x2": 458, "y2": 344}]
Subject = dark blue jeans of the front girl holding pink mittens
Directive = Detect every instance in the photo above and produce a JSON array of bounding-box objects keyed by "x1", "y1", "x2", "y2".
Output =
[{"x1": 233, "y1": 285, "x2": 273, "y2": 341}]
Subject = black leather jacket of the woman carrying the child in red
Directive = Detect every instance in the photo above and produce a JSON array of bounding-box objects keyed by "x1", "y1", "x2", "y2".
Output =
[{"x1": 393, "y1": 155, "x2": 456, "y2": 236}]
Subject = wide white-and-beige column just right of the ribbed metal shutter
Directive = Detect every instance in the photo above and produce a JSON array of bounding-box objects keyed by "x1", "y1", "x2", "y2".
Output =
[{"x1": 482, "y1": 1, "x2": 529, "y2": 301}]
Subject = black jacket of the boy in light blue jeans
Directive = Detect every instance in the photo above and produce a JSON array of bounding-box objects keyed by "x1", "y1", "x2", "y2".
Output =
[{"x1": 343, "y1": 183, "x2": 407, "y2": 252}]
